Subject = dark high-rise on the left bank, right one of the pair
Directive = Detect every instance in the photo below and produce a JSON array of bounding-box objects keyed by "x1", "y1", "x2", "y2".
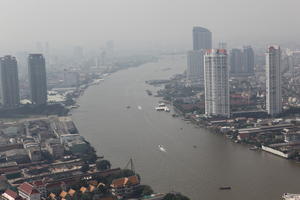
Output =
[{"x1": 28, "y1": 54, "x2": 47, "y2": 105}]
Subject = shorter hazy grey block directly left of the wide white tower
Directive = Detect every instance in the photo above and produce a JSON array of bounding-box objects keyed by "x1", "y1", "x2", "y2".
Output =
[{"x1": 186, "y1": 50, "x2": 204, "y2": 86}]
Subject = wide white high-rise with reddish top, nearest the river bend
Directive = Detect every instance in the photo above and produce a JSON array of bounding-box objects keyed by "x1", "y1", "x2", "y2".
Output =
[{"x1": 204, "y1": 49, "x2": 230, "y2": 117}]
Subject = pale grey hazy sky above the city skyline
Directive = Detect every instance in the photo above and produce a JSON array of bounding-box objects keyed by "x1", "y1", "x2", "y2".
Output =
[{"x1": 0, "y1": 0, "x2": 300, "y2": 50}]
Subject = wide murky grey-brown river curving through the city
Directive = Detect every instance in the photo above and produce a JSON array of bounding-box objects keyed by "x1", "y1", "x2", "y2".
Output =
[{"x1": 72, "y1": 56, "x2": 300, "y2": 200}]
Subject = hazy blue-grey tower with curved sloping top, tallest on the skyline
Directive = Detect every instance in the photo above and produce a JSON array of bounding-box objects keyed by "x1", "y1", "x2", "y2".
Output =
[{"x1": 193, "y1": 26, "x2": 212, "y2": 50}]
